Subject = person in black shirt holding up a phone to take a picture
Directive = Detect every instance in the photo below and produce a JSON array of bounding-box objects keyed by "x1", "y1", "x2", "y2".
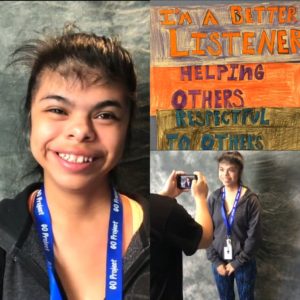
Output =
[{"x1": 150, "y1": 171, "x2": 213, "y2": 300}]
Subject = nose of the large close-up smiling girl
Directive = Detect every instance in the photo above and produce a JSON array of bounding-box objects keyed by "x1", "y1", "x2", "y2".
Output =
[{"x1": 67, "y1": 118, "x2": 96, "y2": 142}]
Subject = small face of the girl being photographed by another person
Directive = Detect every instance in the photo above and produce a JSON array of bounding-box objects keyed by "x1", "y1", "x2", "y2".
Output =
[{"x1": 219, "y1": 161, "x2": 240, "y2": 187}]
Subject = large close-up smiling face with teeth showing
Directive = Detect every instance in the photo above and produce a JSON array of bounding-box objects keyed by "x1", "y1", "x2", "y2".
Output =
[{"x1": 30, "y1": 71, "x2": 129, "y2": 190}]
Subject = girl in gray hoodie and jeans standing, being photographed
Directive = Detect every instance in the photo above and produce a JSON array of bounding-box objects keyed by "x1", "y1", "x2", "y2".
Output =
[{"x1": 207, "y1": 151, "x2": 262, "y2": 300}]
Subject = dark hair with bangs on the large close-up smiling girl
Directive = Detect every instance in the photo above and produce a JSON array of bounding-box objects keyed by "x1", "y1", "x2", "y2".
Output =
[{"x1": 9, "y1": 24, "x2": 137, "y2": 176}]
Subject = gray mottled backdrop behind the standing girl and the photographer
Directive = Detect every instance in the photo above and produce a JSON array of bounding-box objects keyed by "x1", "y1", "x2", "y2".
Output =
[{"x1": 150, "y1": 151, "x2": 300, "y2": 300}]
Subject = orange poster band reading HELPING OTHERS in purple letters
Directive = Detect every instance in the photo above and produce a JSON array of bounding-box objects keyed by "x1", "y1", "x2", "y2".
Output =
[{"x1": 150, "y1": 63, "x2": 300, "y2": 115}]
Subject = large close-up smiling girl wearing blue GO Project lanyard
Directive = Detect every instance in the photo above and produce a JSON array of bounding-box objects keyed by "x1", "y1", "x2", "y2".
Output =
[{"x1": 0, "y1": 27, "x2": 149, "y2": 300}]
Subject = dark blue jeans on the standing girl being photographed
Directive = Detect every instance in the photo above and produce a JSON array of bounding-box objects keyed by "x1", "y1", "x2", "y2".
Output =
[{"x1": 212, "y1": 260, "x2": 256, "y2": 300}]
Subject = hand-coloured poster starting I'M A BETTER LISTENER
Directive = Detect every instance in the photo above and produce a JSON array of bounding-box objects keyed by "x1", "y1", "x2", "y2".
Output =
[{"x1": 150, "y1": 1, "x2": 300, "y2": 150}]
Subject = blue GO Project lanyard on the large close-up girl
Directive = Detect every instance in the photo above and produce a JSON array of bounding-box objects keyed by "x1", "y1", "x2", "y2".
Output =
[{"x1": 33, "y1": 186, "x2": 123, "y2": 300}]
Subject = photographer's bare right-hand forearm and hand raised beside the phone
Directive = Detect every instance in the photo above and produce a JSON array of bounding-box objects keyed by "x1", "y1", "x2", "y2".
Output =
[{"x1": 191, "y1": 172, "x2": 213, "y2": 249}]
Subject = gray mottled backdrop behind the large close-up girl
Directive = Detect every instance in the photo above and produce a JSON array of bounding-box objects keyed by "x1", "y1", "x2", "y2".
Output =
[{"x1": 0, "y1": 1, "x2": 150, "y2": 199}]
